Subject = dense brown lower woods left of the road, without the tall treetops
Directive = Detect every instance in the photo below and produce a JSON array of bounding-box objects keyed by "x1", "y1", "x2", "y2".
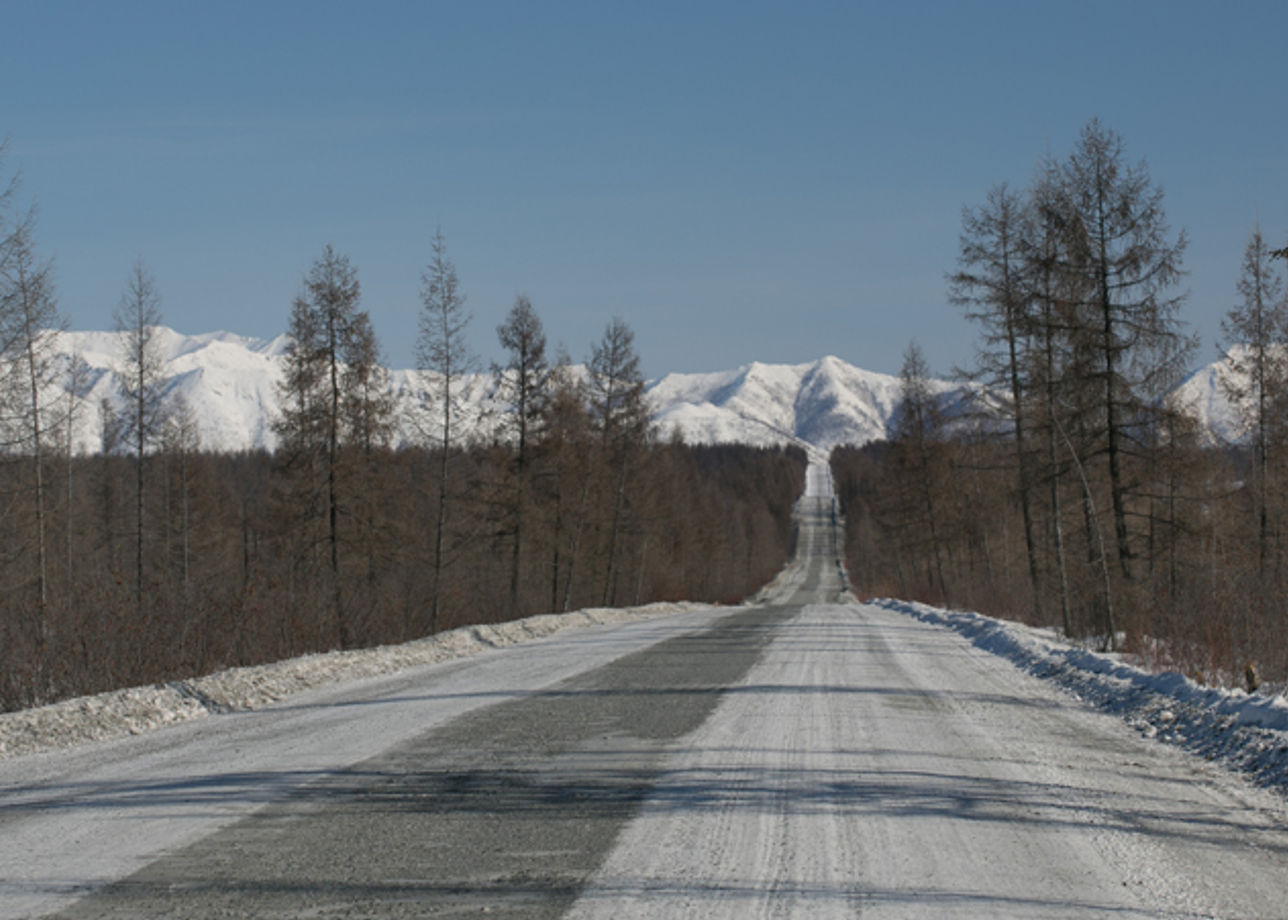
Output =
[{"x1": 0, "y1": 438, "x2": 804, "y2": 709}]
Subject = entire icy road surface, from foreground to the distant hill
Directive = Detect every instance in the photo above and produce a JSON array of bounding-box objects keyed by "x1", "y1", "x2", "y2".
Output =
[{"x1": 0, "y1": 466, "x2": 1288, "y2": 920}]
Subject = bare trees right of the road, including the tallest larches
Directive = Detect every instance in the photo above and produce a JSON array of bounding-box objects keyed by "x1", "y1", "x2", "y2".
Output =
[{"x1": 832, "y1": 121, "x2": 1288, "y2": 683}]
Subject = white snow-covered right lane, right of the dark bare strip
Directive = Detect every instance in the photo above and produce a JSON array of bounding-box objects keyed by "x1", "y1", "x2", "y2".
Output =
[{"x1": 565, "y1": 604, "x2": 1288, "y2": 920}]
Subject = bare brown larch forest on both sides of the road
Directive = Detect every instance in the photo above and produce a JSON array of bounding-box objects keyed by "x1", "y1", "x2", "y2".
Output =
[{"x1": 0, "y1": 120, "x2": 1288, "y2": 709}]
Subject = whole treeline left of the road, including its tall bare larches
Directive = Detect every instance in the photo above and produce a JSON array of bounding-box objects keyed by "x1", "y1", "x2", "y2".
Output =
[{"x1": 0, "y1": 150, "x2": 805, "y2": 709}]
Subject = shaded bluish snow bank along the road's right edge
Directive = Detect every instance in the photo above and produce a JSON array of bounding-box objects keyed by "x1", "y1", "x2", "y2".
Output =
[{"x1": 873, "y1": 599, "x2": 1288, "y2": 789}]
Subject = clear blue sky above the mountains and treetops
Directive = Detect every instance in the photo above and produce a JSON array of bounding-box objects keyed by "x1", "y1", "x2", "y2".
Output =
[{"x1": 0, "y1": 0, "x2": 1288, "y2": 375}]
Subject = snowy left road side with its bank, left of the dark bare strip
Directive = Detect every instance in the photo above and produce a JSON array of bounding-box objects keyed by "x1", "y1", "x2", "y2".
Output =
[{"x1": 0, "y1": 604, "x2": 736, "y2": 919}]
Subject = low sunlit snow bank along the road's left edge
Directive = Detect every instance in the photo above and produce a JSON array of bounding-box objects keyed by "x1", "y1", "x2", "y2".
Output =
[{"x1": 0, "y1": 603, "x2": 710, "y2": 759}]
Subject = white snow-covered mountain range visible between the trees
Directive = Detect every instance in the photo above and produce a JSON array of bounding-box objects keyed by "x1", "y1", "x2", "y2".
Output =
[{"x1": 45, "y1": 327, "x2": 1239, "y2": 451}]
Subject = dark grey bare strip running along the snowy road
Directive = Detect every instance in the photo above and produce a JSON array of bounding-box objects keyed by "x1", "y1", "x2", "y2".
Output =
[{"x1": 45, "y1": 608, "x2": 791, "y2": 920}]
